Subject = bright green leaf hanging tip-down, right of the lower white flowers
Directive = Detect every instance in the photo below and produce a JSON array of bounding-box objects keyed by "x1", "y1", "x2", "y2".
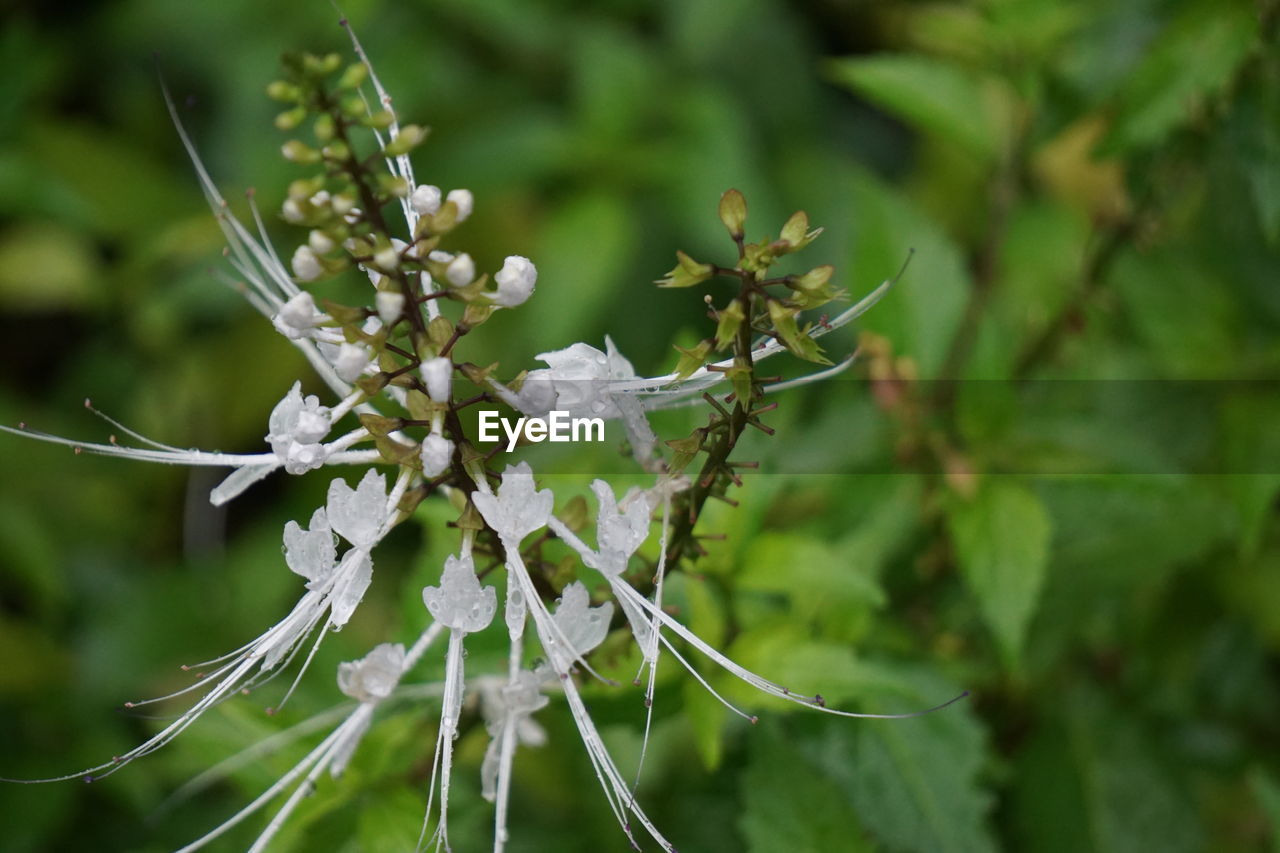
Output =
[{"x1": 947, "y1": 480, "x2": 1051, "y2": 669}]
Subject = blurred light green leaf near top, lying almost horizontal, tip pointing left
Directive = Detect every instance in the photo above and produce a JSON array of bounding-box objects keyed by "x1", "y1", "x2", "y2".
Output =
[{"x1": 827, "y1": 54, "x2": 1000, "y2": 160}]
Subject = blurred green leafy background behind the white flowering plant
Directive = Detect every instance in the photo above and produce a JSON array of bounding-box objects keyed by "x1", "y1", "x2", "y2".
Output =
[{"x1": 0, "y1": 0, "x2": 1280, "y2": 853}]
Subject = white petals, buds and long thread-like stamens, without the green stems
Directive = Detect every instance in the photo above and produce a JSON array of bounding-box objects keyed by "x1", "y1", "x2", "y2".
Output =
[{"x1": 0, "y1": 29, "x2": 926, "y2": 850}]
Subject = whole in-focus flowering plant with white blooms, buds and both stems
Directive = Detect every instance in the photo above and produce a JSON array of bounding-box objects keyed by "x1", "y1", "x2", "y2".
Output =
[{"x1": 3, "y1": 26, "x2": 954, "y2": 852}]
